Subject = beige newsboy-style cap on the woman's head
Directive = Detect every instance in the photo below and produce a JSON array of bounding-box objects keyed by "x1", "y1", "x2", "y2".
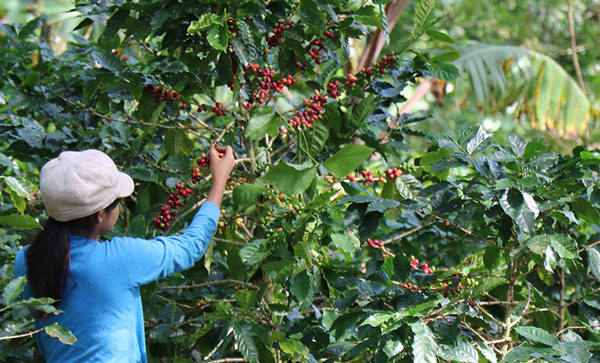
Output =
[{"x1": 40, "y1": 150, "x2": 133, "y2": 222}]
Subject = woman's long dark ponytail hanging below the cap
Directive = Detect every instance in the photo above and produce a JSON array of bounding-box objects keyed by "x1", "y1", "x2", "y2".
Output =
[{"x1": 25, "y1": 199, "x2": 120, "y2": 318}]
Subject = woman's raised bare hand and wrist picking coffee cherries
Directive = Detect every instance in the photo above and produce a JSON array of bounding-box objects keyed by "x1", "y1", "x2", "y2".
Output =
[{"x1": 206, "y1": 146, "x2": 235, "y2": 207}]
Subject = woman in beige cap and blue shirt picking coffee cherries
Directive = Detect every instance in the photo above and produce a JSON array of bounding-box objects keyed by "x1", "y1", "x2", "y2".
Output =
[{"x1": 15, "y1": 146, "x2": 234, "y2": 363}]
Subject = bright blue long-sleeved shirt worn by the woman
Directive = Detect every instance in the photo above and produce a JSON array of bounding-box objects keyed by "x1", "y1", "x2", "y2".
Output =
[{"x1": 15, "y1": 202, "x2": 220, "y2": 363}]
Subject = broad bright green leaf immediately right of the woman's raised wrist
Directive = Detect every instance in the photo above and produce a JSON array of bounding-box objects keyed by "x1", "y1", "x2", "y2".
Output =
[{"x1": 258, "y1": 162, "x2": 317, "y2": 195}]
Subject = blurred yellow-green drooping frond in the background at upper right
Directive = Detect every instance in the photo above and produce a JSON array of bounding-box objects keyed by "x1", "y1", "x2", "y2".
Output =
[{"x1": 454, "y1": 45, "x2": 593, "y2": 136}]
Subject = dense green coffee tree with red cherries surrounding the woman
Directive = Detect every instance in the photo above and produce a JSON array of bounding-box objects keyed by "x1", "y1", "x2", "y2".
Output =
[{"x1": 0, "y1": 0, "x2": 600, "y2": 362}]
